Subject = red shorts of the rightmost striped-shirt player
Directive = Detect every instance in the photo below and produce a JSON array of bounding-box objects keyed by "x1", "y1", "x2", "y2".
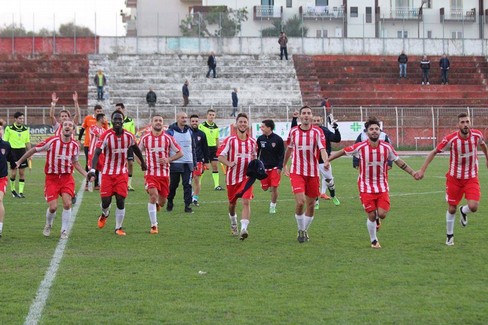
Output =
[{"x1": 446, "y1": 175, "x2": 481, "y2": 205}]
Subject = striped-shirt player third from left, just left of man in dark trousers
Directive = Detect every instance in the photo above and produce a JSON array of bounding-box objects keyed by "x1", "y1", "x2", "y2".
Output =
[{"x1": 139, "y1": 114, "x2": 183, "y2": 234}]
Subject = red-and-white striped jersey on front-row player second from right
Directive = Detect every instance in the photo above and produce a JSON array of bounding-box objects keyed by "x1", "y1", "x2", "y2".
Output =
[{"x1": 344, "y1": 140, "x2": 398, "y2": 193}]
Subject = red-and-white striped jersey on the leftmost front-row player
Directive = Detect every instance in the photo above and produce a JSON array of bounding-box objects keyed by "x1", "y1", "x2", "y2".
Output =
[{"x1": 35, "y1": 136, "x2": 80, "y2": 174}]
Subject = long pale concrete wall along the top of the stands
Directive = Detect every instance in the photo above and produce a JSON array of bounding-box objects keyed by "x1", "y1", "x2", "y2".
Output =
[{"x1": 99, "y1": 37, "x2": 488, "y2": 56}]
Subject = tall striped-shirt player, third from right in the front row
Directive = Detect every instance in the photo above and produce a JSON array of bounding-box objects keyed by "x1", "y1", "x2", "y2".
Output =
[{"x1": 283, "y1": 106, "x2": 329, "y2": 243}]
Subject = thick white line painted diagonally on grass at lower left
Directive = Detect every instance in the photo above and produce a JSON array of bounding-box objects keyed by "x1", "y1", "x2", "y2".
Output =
[{"x1": 24, "y1": 182, "x2": 85, "y2": 325}]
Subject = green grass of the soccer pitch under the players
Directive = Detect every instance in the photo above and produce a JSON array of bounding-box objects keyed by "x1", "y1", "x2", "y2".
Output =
[{"x1": 0, "y1": 157, "x2": 488, "y2": 324}]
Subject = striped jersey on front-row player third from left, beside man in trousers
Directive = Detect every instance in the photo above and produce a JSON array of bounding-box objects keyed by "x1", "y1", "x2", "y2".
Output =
[{"x1": 139, "y1": 132, "x2": 181, "y2": 176}]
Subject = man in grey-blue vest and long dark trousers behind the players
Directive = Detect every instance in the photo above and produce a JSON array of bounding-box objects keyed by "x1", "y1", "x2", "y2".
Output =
[{"x1": 166, "y1": 112, "x2": 197, "y2": 213}]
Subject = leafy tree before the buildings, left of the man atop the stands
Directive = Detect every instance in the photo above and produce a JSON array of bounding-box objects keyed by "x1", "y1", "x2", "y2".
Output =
[{"x1": 180, "y1": 6, "x2": 248, "y2": 37}]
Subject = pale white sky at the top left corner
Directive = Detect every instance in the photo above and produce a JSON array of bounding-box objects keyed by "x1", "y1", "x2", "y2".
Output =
[{"x1": 0, "y1": 0, "x2": 128, "y2": 36}]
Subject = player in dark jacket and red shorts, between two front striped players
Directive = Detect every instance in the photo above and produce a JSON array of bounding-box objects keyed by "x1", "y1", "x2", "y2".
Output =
[{"x1": 256, "y1": 120, "x2": 285, "y2": 214}]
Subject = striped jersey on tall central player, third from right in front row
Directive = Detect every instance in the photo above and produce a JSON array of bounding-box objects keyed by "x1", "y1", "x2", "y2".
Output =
[{"x1": 287, "y1": 126, "x2": 326, "y2": 177}]
